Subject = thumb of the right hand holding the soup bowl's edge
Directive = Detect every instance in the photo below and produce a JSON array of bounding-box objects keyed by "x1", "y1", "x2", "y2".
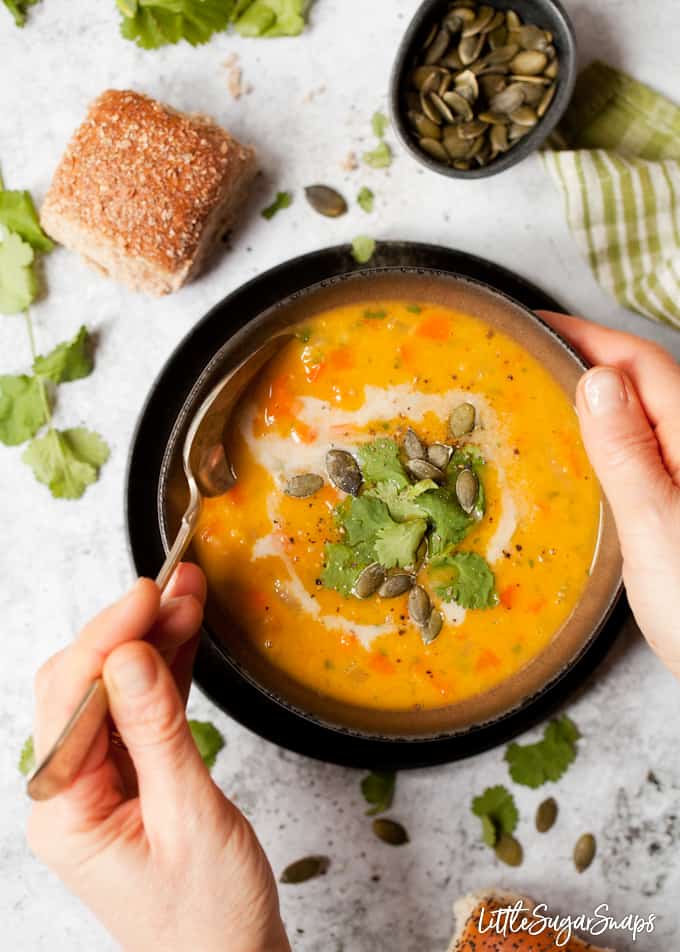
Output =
[{"x1": 576, "y1": 367, "x2": 670, "y2": 548}]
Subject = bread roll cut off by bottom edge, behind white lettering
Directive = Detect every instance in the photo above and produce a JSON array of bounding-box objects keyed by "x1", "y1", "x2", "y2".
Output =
[{"x1": 448, "y1": 889, "x2": 614, "y2": 952}]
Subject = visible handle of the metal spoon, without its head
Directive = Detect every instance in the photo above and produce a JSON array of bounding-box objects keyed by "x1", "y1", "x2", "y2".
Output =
[{"x1": 26, "y1": 500, "x2": 200, "y2": 800}]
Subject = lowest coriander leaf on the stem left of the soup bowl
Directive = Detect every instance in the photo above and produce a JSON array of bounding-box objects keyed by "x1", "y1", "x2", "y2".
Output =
[{"x1": 22, "y1": 427, "x2": 109, "y2": 499}]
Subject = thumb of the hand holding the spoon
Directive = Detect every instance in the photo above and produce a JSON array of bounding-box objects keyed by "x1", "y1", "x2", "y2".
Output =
[{"x1": 104, "y1": 641, "x2": 212, "y2": 833}]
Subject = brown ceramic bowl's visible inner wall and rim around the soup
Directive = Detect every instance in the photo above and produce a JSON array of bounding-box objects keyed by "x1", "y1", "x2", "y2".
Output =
[{"x1": 158, "y1": 268, "x2": 621, "y2": 741}]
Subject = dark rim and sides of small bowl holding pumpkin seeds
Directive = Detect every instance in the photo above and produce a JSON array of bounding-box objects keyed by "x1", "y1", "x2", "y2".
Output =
[{"x1": 388, "y1": 0, "x2": 578, "y2": 180}]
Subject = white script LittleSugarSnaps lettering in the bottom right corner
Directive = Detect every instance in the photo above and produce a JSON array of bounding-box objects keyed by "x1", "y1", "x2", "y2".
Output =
[{"x1": 479, "y1": 899, "x2": 656, "y2": 949}]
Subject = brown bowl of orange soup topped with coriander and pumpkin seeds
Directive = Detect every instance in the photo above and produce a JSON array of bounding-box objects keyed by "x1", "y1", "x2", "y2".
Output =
[{"x1": 158, "y1": 268, "x2": 621, "y2": 740}]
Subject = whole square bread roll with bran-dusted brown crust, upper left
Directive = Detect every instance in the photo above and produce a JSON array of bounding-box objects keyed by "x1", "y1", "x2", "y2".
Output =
[{"x1": 40, "y1": 89, "x2": 256, "y2": 294}]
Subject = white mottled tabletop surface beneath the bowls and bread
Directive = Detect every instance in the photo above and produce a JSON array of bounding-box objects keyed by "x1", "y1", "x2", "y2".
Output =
[{"x1": 0, "y1": 0, "x2": 680, "y2": 952}]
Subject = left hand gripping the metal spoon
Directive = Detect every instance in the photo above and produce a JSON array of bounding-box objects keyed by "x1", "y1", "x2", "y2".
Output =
[{"x1": 28, "y1": 564, "x2": 290, "y2": 952}]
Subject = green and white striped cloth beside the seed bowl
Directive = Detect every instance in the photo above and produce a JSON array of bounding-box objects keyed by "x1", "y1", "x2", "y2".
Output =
[{"x1": 543, "y1": 62, "x2": 680, "y2": 328}]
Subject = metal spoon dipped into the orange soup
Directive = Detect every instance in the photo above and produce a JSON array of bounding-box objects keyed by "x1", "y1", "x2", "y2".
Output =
[{"x1": 26, "y1": 333, "x2": 293, "y2": 800}]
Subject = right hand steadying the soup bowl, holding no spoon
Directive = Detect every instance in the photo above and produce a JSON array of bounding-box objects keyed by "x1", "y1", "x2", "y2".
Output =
[{"x1": 539, "y1": 311, "x2": 680, "y2": 677}]
